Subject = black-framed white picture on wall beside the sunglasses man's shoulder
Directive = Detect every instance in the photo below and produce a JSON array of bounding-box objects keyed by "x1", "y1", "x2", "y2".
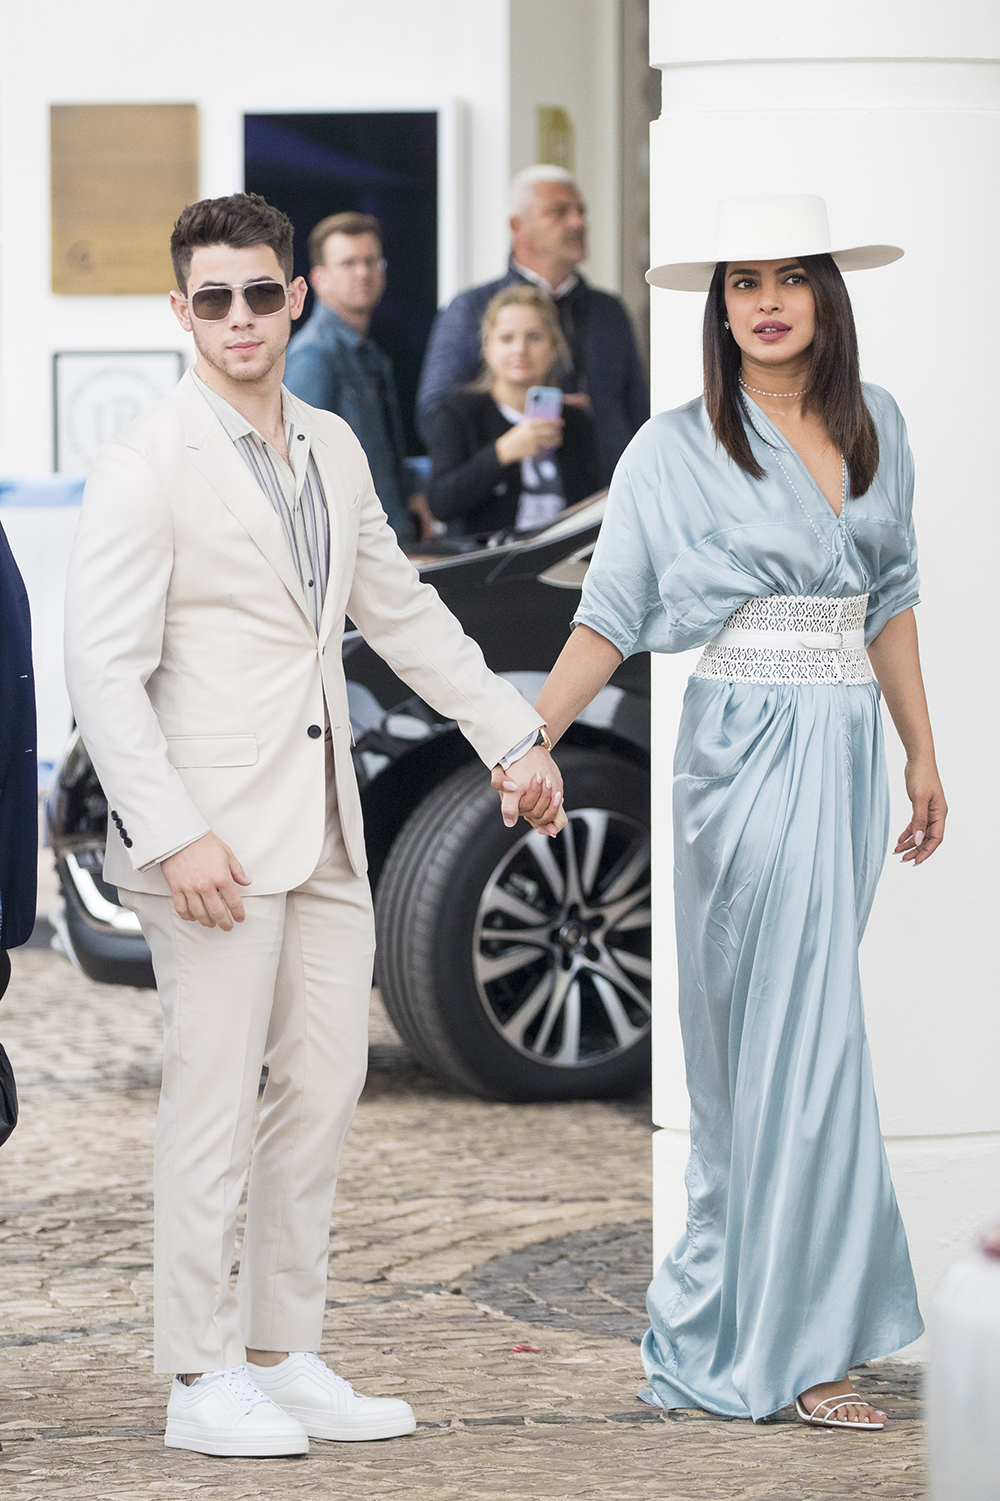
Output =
[{"x1": 53, "y1": 350, "x2": 185, "y2": 474}]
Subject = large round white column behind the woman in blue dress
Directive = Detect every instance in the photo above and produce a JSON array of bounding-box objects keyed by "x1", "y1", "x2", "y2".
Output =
[{"x1": 650, "y1": 0, "x2": 1000, "y2": 1349}]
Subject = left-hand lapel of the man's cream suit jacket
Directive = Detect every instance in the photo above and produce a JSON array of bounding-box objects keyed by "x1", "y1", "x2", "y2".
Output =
[{"x1": 174, "y1": 381, "x2": 312, "y2": 626}]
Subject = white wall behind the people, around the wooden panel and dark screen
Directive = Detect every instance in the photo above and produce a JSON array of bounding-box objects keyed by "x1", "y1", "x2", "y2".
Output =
[{"x1": 0, "y1": 0, "x2": 619, "y2": 476}]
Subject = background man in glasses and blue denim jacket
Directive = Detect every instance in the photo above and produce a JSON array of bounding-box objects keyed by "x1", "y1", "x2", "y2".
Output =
[{"x1": 284, "y1": 212, "x2": 431, "y2": 546}]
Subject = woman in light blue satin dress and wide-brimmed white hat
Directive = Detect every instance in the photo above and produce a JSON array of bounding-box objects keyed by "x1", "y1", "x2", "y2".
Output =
[{"x1": 510, "y1": 195, "x2": 946, "y2": 1429}]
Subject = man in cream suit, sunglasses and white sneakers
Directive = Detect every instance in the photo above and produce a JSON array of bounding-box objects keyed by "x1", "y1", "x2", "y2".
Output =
[{"x1": 66, "y1": 194, "x2": 565, "y2": 1454}]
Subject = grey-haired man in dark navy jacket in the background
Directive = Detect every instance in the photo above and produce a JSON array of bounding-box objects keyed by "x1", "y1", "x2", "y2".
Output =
[{"x1": 417, "y1": 167, "x2": 649, "y2": 485}]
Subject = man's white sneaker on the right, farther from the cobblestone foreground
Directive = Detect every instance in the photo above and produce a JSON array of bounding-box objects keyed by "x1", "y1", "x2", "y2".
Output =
[{"x1": 246, "y1": 1352, "x2": 416, "y2": 1442}]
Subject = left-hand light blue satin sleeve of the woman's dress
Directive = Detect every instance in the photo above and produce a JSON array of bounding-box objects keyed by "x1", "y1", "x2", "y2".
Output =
[{"x1": 574, "y1": 462, "x2": 664, "y2": 657}]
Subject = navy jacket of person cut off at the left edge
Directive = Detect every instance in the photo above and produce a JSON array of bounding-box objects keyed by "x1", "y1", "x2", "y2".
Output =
[{"x1": 0, "y1": 527, "x2": 38, "y2": 995}]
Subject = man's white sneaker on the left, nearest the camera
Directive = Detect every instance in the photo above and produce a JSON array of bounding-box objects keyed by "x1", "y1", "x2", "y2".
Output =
[{"x1": 164, "y1": 1366, "x2": 309, "y2": 1456}]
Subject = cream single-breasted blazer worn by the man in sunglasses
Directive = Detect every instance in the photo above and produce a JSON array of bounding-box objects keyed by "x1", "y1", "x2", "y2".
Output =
[{"x1": 66, "y1": 375, "x2": 542, "y2": 895}]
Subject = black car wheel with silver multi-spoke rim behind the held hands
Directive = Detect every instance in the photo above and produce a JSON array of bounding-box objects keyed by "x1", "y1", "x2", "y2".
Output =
[{"x1": 375, "y1": 746, "x2": 650, "y2": 1100}]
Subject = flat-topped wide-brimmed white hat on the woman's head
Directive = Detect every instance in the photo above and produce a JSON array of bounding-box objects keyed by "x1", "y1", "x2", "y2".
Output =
[{"x1": 646, "y1": 192, "x2": 902, "y2": 291}]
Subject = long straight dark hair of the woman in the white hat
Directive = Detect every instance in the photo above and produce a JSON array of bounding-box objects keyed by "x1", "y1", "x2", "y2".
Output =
[{"x1": 703, "y1": 255, "x2": 878, "y2": 495}]
